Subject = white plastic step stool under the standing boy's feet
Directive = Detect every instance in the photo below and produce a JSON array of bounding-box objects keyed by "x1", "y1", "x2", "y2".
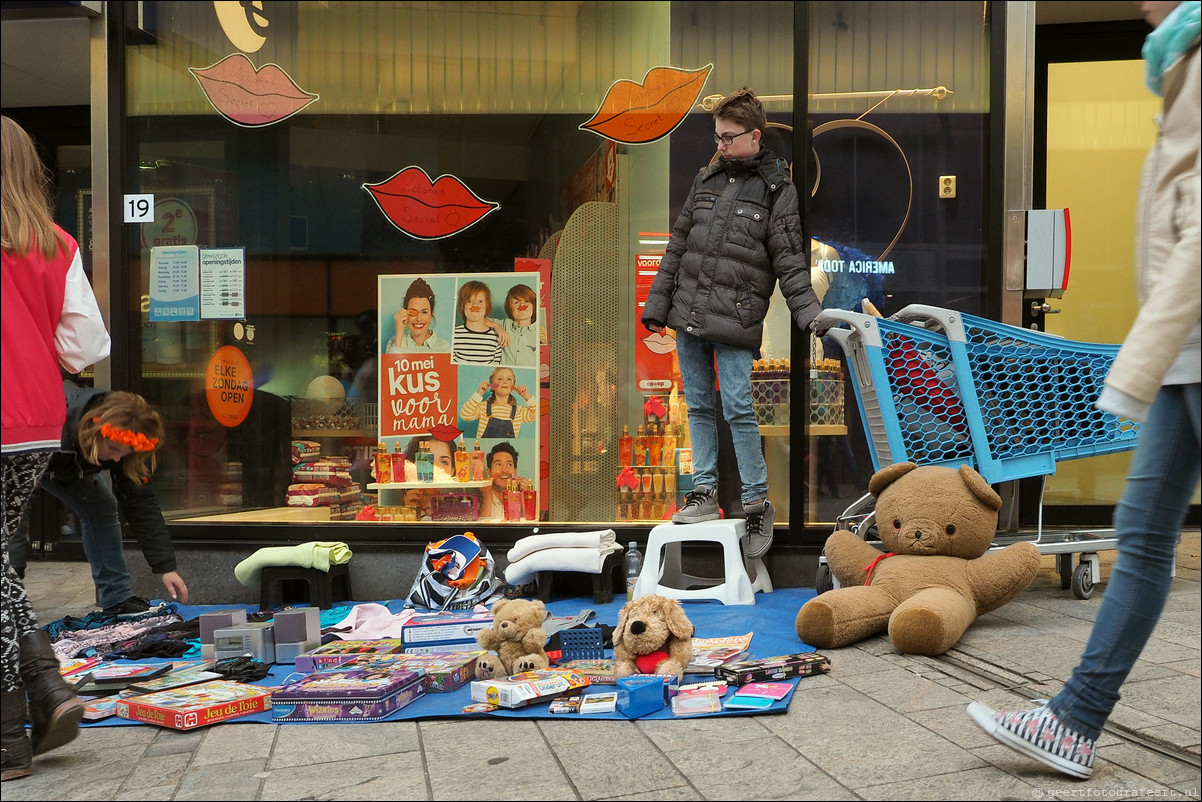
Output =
[{"x1": 635, "y1": 518, "x2": 772, "y2": 605}]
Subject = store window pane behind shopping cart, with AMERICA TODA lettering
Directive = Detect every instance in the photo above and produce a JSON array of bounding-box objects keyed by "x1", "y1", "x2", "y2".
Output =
[{"x1": 795, "y1": 2, "x2": 992, "y2": 521}]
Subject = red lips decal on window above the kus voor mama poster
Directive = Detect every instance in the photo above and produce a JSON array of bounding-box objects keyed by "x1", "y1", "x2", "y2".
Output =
[{"x1": 363, "y1": 166, "x2": 501, "y2": 239}]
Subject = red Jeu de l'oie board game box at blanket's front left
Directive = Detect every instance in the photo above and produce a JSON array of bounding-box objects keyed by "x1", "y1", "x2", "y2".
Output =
[{"x1": 117, "y1": 679, "x2": 272, "y2": 730}]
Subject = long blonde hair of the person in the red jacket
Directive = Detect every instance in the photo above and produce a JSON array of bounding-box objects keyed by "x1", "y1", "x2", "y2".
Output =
[{"x1": 0, "y1": 115, "x2": 64, "y2": 259}]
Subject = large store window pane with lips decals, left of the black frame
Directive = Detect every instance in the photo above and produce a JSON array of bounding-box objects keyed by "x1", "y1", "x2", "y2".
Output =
[{"x1": 125, "y1": 2, "x2": 793, "y2": 533}]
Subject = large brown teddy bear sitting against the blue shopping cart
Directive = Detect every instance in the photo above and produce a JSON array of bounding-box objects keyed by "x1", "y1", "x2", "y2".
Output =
[{"x1": 797, "y1": 462, "x2": 1040, "y2": 655}]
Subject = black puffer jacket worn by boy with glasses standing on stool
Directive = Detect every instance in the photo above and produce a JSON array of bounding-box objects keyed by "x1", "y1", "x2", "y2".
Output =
[{"x1": 642, "y1": 148, "x2": 822, "y2": 350}]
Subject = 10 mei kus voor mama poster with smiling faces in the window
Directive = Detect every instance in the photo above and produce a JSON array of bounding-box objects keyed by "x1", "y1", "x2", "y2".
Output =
[{"x1": 377, "y1": 273, "x2": 546, "y2": 521}]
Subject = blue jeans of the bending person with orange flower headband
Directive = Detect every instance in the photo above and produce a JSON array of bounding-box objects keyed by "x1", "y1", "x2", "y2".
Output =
[{"x1": 42, "y1": 474, "x2": 133, "y2": 607}]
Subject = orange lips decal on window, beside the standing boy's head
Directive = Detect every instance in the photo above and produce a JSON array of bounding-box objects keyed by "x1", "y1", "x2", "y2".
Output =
[{"x1": 581, "y1": 64, "x2": 714, "y2": 144}]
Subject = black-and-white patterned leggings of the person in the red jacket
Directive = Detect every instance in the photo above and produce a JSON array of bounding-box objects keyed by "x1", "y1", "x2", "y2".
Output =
[{"x1": 0, "y1": 451, "x2": 53, "y2": 693}]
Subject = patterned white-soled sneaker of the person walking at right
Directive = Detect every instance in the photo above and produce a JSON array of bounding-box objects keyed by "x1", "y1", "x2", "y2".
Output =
[{"x1": 969, "y1": 702, "x2": 1094, "y2": 779}]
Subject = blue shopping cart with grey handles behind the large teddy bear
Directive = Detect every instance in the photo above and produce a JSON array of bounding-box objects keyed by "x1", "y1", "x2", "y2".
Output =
[{"x1": 816, "y1": 304, "x2": 1138, "y2": 599}]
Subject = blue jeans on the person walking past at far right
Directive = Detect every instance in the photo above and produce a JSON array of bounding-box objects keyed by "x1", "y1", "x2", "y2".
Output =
[{"x1": 1048, "y1": 384, "x2": 1202, "y2": 739}]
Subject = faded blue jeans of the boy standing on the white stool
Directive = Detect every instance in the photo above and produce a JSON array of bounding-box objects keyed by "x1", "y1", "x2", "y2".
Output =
[{"x1": 677, "y1": 331, "x2": 768, "y2": 504}]
